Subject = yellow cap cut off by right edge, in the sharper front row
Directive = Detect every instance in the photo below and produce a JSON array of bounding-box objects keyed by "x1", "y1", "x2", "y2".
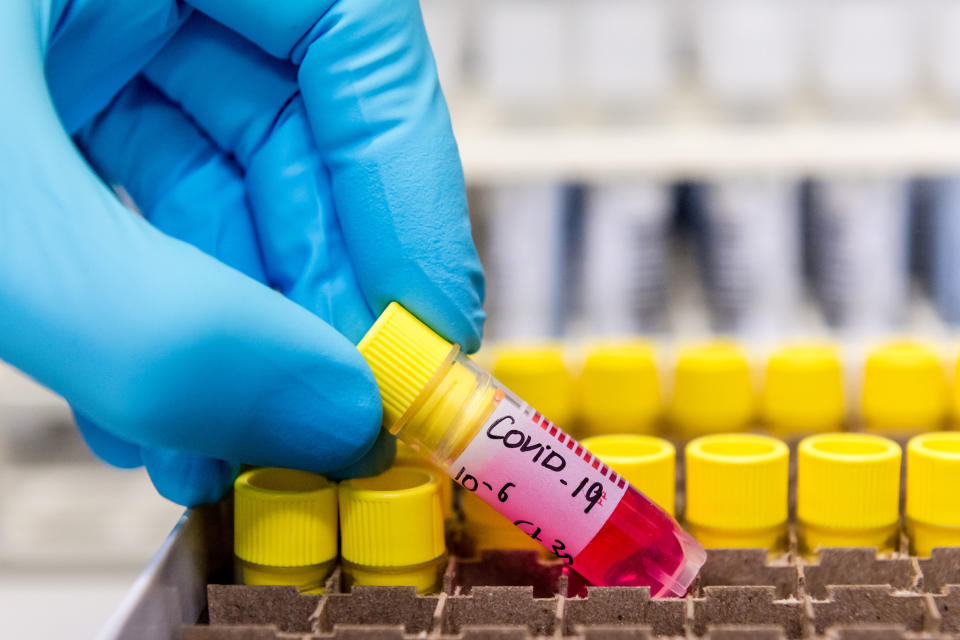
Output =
[{"x1": 905, "y1": 432, "x2": 960, "y2": 556}]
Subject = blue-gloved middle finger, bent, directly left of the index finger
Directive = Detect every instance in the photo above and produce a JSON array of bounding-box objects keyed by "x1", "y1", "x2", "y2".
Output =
[{"x1": 144, "y1": 14, "x2": 373, "y2": 342}]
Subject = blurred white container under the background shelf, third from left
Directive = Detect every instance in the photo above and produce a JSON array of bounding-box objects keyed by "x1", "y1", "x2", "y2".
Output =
[{"x1": 697, "y1": 177, "x2": 803, "y2": 337}]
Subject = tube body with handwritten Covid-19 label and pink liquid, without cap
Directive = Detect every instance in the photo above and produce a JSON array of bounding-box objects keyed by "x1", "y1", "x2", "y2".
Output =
[{"x1": 447, "y1": 396, "x2": 706, "y2": 597}]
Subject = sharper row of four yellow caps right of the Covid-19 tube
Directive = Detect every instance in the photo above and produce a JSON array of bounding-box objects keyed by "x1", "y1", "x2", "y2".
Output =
[{"x1": 584, "y1": 432, "x2": 960, "y2": 556}]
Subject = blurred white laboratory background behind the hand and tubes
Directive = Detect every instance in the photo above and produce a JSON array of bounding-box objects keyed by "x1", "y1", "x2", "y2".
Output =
[{"x1": 0, "y1": 0, "x2": 960, "y2": 638}]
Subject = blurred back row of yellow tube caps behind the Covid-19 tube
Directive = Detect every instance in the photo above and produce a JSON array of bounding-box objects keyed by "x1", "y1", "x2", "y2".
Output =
[{"x1": 492, "y1": 340, "x2": 960, "y2": 437}]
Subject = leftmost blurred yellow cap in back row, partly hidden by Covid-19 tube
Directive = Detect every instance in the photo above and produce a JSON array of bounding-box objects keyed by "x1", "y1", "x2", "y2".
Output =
[{"x1": 493, "y1": 344, "x2": 573, "y2": 428}]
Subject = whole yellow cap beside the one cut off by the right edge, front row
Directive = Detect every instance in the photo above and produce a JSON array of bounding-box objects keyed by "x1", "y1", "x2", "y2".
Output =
[{"x1": 797, "y1": 433, "x2": 901, "y2": 529}]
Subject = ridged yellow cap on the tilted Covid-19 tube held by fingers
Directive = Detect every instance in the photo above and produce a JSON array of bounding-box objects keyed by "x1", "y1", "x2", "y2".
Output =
[{"x1": 357, "y1": 302, "x2": 454, "y2": 431}]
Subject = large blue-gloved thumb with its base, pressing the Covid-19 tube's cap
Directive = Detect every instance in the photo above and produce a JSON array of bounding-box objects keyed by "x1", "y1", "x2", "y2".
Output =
[{"x1": 0, "y1": 2, "x2": 380, "y2": 472}]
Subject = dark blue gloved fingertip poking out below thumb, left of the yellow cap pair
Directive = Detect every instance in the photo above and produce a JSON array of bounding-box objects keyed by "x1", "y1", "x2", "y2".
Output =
[{"x1": 142, "y1": 447, "x2": 240, "y2": 507}]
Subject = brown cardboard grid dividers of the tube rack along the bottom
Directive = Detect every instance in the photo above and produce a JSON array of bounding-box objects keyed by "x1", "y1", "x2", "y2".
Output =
[{"x1": 182, "y1": 444, "x2": 960, "y2": 640}]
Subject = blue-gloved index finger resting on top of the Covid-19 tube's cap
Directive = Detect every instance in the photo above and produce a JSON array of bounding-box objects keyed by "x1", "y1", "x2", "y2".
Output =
[{"x1": 186, "y1": 0, "x2": 484, "y2": 350}]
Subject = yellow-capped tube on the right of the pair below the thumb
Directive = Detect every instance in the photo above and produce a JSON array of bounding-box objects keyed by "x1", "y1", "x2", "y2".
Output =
[{"x1": 339, "y1": 465, "x2": 447, "y2": 594}]
